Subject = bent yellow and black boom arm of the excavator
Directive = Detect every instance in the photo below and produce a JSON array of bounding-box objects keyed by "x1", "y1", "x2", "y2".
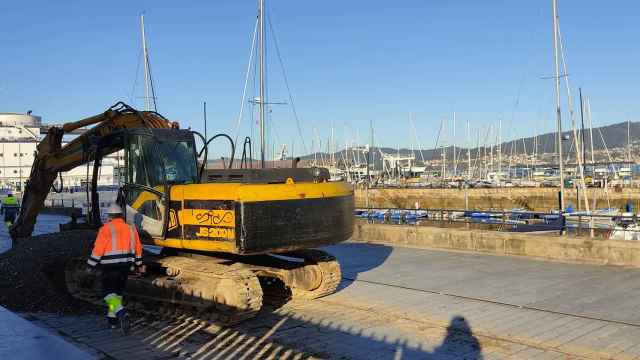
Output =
[{"x1": 9, "y1": 102, "x2": 178, "y2": 239}]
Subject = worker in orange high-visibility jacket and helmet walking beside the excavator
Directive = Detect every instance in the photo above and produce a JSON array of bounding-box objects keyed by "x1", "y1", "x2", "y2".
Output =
[{"x1": 87, "y1": 204, "x2": 142, "y2": 333}]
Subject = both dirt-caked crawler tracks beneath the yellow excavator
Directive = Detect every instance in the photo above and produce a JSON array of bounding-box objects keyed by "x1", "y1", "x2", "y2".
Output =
[{"x1": 65, "y1": 249, "x2": 342, "y2": 325}]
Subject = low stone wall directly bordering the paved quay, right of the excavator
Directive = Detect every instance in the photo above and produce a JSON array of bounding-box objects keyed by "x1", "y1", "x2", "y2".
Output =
[{"x1": 351, "y1": 221, "x2": 640, "y2": 267}]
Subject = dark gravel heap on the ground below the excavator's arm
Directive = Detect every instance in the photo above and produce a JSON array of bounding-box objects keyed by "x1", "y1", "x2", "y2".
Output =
[{"x1": 0, "y1": 230, "x2": 99, "y2": 314}]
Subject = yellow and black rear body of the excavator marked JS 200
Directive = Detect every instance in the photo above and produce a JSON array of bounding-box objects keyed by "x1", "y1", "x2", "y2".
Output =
[{"x1": 138, "y1": 180, "x2": 354, "y2": 254}]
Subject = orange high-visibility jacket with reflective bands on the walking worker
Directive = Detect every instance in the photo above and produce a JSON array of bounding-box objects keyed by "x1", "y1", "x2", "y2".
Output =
[{"x1": 87, "y1": 219, "x2": 142, "y2": 267}]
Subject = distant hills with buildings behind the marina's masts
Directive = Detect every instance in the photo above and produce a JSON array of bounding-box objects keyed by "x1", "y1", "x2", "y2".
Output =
[{"x1": 302, "y1": 122, "x2": 640, "y2": 168}]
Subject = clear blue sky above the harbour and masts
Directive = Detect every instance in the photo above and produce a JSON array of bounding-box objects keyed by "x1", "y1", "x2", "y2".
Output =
[{"x1": 0, "y1": 0, "x2": 640, "y2": 153}]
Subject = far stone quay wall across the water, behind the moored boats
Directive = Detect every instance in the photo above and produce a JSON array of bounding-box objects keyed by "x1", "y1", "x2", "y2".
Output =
[{"x1": 355, "y1": 188, "x2": 640, "y2": 211}]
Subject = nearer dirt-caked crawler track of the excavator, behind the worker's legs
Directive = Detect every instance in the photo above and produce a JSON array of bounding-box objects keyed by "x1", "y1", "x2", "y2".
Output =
[{"x1": 65, "y1": 256, "x2": 262, "y2": 325}]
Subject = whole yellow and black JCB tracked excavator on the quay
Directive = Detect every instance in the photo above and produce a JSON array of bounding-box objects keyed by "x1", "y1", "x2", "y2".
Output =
[{"x1": 10, "y1": 102, "x2": 354, "y2": 322}]
